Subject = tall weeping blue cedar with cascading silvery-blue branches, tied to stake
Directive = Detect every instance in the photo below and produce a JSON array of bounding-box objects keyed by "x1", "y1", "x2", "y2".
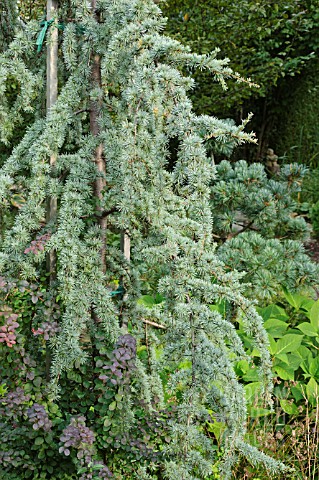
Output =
[{"x1": 0, "y1": 0, "x2": 284, "y2": 480}]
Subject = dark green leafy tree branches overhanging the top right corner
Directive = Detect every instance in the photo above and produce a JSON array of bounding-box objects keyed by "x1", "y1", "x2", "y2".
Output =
[{"x1": 163, "y1": 0, "x2": 319, "y2": 115}]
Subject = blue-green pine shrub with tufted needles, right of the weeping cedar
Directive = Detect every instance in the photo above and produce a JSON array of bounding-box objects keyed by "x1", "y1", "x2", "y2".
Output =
[{"x1": 211, "y1": 160, "x2": 318, "y2": 302}]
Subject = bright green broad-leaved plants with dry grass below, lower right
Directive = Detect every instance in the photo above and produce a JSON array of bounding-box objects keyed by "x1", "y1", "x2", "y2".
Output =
[{"x1": 235, "y1": 291, "x2": 319, "y2": 479}]
